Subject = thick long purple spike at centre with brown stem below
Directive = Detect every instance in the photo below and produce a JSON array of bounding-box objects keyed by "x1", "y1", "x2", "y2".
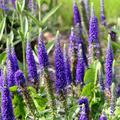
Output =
[{"x1": 55, "y1": 32, "x2": 68, "y2": 119}]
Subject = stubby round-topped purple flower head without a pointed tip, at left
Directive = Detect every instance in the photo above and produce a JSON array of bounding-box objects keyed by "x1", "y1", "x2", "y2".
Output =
[{"x1": 15, "y1": 70, "x2": 26, "y2": 87}]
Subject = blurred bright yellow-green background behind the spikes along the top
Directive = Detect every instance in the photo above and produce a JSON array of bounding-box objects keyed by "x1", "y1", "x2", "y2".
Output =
[{"x1": 46, "y1": 0, "x2": 120, "y2": 29}]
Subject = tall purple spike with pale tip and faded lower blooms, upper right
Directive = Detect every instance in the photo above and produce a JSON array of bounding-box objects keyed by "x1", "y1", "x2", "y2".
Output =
[{"x1": 88, "y1": 5, "x2": 100, "y2": 64}]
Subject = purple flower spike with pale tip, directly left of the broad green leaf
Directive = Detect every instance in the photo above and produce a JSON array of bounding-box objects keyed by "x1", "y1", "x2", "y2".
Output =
[{"x1": 76, "y1": 44, "x2": 85, "y2": 85}]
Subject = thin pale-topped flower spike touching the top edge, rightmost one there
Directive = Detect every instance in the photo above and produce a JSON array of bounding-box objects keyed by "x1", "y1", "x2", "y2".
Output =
[{"x1": 100, "y1": 0, "x2": 106, "y2": 26}]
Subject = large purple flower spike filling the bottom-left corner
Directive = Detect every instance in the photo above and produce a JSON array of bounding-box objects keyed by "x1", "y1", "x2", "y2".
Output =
[{"x1": 1, "y1": 75, "x2": 15, "y2": 120}]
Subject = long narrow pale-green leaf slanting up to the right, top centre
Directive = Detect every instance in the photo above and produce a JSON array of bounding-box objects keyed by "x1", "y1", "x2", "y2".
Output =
[{"x1": 42, "y1": 4, "x2": 62, "y2": 25}]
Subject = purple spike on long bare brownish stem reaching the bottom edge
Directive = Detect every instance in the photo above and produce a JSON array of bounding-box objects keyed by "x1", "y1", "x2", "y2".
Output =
[{"x1": 38, "y1": 32, "x2": 56, "y2": 120}]
